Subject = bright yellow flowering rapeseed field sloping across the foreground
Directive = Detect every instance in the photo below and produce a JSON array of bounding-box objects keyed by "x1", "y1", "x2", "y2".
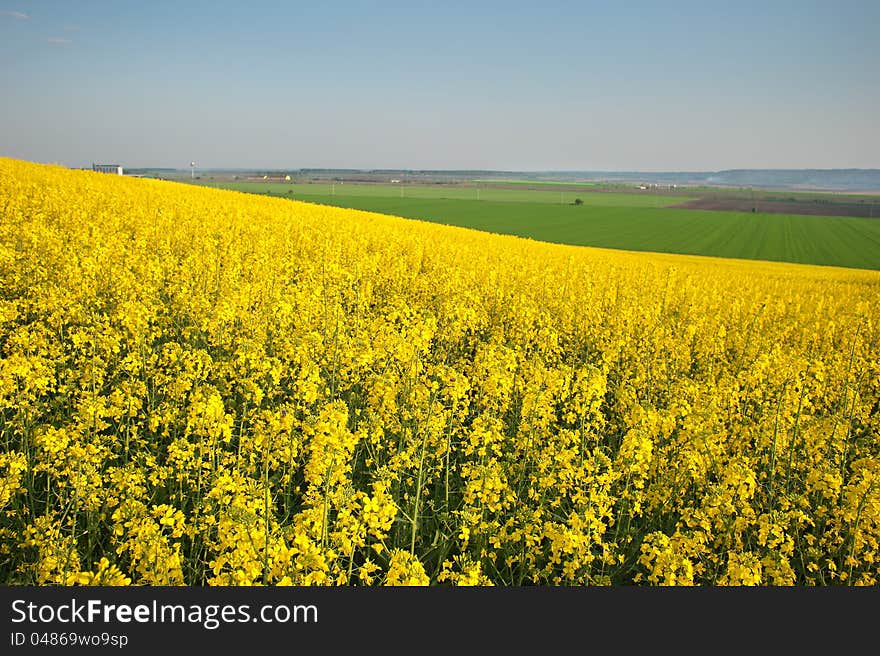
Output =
[{"x1": 0, "y1": 159, "x2": 880, "y2": 586}]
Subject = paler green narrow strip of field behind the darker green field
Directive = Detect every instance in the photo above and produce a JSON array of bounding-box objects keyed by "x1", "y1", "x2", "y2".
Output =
[{"x1": 202, "y1": 181, "x2": 694, "y2": 207}]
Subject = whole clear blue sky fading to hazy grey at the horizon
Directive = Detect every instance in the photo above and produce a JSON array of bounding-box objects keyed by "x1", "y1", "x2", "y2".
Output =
[{"x1": 0, "y1": 0, "x2": 880, "y2": 171}]
